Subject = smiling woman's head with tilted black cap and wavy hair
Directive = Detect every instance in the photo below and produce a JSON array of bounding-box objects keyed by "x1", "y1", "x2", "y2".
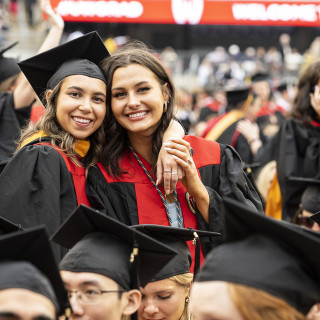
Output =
[{"x1": 19, "y1": 32, "x2": 109, "y2": 168}]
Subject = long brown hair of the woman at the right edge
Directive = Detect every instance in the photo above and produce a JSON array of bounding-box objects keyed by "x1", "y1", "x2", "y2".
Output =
[{"x1": 291, "y1": 60, "x2": 320, "y2": 126}]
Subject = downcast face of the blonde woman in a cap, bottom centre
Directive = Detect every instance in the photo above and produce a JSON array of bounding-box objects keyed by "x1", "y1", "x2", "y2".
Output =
[{"x1": 138, "y1": 279, "x2": 188, "y2": 320}]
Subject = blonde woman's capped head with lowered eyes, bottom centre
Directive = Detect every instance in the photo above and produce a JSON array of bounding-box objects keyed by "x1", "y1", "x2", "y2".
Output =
[{"x1": 133, "y1": 224, "x2": 218, "y2": 320}]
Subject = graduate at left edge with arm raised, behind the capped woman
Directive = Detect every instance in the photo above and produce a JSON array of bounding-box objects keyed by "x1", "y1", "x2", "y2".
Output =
[{"x1": 0, "y1": 0, "x2": 64, "y2": 174}]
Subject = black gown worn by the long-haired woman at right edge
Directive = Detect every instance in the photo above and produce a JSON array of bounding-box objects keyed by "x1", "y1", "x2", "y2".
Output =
[{"x1": 256, "y1": 119, "x2": 320, "y2": 221}]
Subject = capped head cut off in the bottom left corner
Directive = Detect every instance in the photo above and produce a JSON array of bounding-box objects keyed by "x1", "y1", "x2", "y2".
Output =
[{"x1": 0, "y1": 227, "x2": 70, "y2": 320}]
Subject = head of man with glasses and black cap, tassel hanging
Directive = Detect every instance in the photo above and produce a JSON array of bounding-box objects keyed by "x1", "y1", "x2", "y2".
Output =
[{"x1": 52, "y1": 206, "x2": 176, "y2": 320}]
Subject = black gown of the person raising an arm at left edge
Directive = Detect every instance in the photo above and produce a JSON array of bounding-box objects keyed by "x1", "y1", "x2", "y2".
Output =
[{"x1": 0, "y1": 92, "x2": 31, "y2": 173}]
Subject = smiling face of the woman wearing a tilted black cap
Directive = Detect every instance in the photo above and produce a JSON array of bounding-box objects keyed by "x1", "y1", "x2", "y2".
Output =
[{"x1": 52, "y1": 75, "x2": 106, "y2": 140}]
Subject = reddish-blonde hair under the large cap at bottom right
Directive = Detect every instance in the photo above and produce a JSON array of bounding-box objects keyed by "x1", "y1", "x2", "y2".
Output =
[{"x1": 228, "y1": 283, "x2": 306, "y2": 320}]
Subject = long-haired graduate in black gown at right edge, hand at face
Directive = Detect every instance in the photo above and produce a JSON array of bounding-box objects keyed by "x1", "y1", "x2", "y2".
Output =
[{"x1": 255, "y1": 61, "x2": 320, "y2": 221}]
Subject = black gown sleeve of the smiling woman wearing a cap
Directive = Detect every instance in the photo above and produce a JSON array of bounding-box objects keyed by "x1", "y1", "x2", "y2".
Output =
[{"x1": 0, "y1": 145, "x2": 77, "y2": 261}]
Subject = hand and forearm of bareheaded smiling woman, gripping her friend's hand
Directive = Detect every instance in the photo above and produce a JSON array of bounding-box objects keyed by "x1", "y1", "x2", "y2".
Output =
[{"x1": 164, "y1": 139, "x2": 209, "y2": 220}]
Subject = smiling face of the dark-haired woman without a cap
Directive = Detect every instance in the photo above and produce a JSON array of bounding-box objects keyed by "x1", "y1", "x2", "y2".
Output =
[{"x1": 111, "y1": 64, "x2": 168, "y2": 141}]
